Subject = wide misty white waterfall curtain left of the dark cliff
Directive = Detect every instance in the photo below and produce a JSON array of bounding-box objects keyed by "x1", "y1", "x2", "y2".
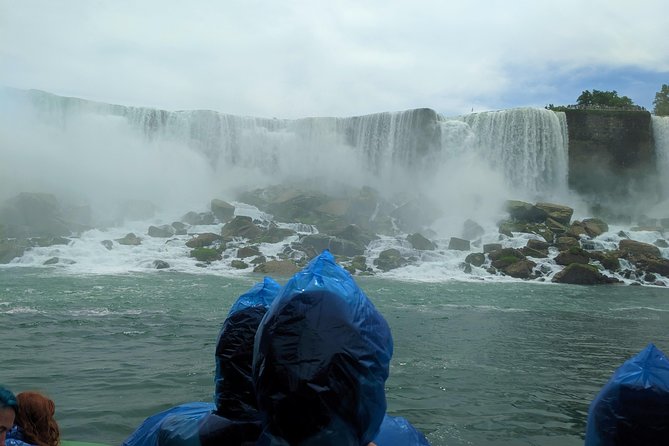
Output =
[{"x1": 0, "y1": 89, "x2": 567, "y2": 215}]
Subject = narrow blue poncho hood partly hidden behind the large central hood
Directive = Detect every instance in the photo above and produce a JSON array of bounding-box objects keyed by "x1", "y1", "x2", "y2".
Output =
[{"x1": 214, "y1": 277, "x2": 281, "y2": 420}]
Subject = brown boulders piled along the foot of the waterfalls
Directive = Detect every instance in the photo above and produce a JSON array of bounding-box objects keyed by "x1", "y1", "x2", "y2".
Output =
[{"x1": 0, "y1": 185, "x2": 669, "y2": 286}]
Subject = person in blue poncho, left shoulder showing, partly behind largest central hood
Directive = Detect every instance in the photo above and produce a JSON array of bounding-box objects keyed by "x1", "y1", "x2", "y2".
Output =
[{"x1": 123, "y1": 277, "x2": 280, "y2": 446}]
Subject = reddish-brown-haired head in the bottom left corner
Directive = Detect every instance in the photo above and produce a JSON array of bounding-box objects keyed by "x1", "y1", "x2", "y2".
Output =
[{"x1": 15, "y1": 392, "x2": 60, "y2": 446}]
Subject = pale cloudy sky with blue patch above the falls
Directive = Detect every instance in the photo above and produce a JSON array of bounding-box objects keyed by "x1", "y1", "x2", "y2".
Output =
[{"x1": 0, "y1": 0, "x2": 669, "y2": 118}]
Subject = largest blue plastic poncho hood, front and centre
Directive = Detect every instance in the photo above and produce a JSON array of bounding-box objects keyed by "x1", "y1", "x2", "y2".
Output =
[{"x1": 253, "y1": 251, "x2": 393, "y2": 446}]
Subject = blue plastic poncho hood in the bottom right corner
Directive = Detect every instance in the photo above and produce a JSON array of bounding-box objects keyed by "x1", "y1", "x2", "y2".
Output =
[{"x1": 585, "y1": 344, "x2": 669, "y2": 446}]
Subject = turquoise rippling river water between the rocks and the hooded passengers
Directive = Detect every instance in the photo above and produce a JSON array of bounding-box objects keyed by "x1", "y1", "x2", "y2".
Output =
[{"x1": 0, "y1": 268, "x2": 669, "y2": 446}]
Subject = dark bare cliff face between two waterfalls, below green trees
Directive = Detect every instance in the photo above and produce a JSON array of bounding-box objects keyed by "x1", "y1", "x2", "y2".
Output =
[{"x1": 565, "y1": 109, "x2": 658, "y2": 198}]
